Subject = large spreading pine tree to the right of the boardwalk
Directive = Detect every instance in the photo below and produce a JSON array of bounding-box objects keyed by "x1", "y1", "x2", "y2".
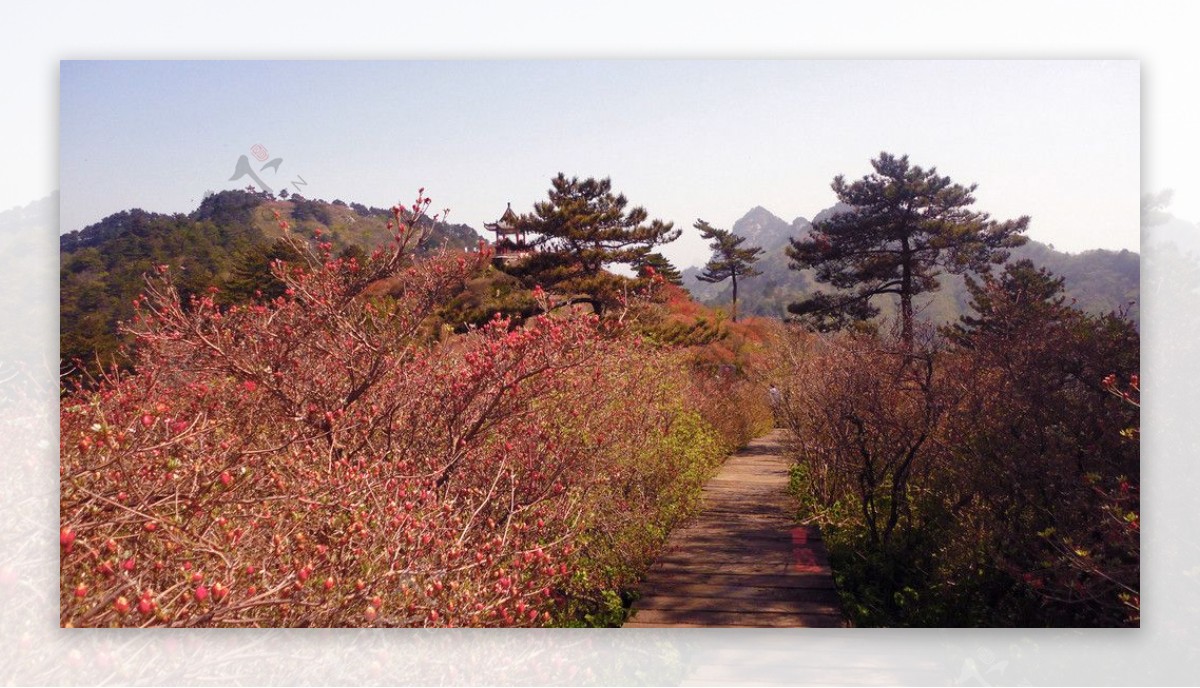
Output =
[{"x1": 787, "y1": 152, "x2": 1030, "y2": 349}]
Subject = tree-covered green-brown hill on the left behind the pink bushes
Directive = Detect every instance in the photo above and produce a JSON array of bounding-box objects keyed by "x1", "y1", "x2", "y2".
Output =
[{"x1": 59, "y1": 191, "x2": 481, "y2": 374}]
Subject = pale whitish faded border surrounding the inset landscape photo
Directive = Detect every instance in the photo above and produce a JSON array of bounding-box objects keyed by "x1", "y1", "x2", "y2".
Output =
[{"x1": 0, "y1": 1, "x2": 1200, "y2": 686}]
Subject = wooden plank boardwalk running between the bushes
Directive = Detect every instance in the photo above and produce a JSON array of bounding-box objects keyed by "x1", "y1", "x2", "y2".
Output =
[{"x1": 625, "y1": 430, "x2": 845, "y2": 628}]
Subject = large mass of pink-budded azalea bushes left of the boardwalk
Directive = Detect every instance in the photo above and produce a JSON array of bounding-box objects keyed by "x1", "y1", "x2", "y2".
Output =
[{"x1": 60, "y1": 196, "x2": 720, "y2": 627}]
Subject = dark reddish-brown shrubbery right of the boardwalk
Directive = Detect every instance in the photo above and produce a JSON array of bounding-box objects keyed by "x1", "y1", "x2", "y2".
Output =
[{"x1": 778, "y1": 263, "x2": 1140, "y2": 626}]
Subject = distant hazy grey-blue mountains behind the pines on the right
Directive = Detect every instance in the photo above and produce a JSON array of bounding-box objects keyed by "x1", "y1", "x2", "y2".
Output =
[{"x1": 683, "y1": 204, "x2": 1140, "y2": 324}]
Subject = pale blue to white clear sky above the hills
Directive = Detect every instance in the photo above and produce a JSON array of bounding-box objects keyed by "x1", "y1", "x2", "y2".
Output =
[{"x1": 59, "y1": 59, "x2": 1141, "y2": 267}]
